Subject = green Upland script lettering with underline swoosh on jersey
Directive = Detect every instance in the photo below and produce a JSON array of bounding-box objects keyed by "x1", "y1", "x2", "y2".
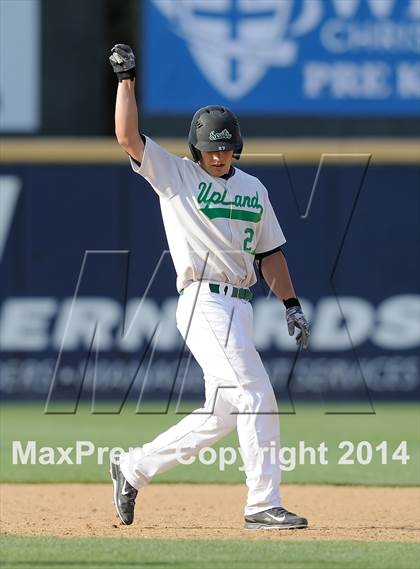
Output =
[{"x1": 197, "y1": 182, "x2": 264, "y2": 223}]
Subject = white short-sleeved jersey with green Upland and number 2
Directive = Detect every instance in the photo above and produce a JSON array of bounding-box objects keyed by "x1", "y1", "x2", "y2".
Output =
[{"x1": 130, "y1": 137, "x2": 286, "y2": 291}]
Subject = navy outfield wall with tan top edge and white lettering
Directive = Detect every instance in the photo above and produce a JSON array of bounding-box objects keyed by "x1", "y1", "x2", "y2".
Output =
[{"x1": 0, "y1": 140, "x2": 420, "y2": 400}]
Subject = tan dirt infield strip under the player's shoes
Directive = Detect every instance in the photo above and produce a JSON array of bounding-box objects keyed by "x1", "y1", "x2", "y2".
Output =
[{"x1": 0, "y1": 484, "x2": 420, "y2": 542}]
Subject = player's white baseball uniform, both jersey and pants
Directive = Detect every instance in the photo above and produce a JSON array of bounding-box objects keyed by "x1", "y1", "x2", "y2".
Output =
[{"x1": 120, "y1": 138, "x2": 285, "y2": 515}]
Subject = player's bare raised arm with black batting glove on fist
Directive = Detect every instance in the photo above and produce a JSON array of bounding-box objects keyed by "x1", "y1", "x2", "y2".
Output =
[{"x1": 109, "y1": 44, "x2": 144, "y2": 162}]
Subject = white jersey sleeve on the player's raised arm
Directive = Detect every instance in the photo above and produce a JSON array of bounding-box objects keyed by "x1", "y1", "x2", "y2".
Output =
[{"x1": 129, "y1": 136, "x2": 185, "y2": 199}]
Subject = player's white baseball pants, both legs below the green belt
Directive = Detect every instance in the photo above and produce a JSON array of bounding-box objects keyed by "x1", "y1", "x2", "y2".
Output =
[{"x1": 120, "y1": 282, "x2": 280, "y2": 515}]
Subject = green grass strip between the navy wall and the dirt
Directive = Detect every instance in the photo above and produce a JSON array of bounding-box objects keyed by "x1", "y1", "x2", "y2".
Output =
[{"x1": 0, "y1": 403, "x2": 420, "y2": 485}]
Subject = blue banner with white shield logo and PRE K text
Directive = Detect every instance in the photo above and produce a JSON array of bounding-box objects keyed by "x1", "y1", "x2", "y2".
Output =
[{"x1": 144, "y1": 0, "x2": 420, "y2": 116}]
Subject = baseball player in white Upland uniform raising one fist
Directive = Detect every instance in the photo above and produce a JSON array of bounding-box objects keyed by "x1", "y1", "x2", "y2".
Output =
[{"x1": 110, "y1": 44, "x2": 309, "y2": 529}]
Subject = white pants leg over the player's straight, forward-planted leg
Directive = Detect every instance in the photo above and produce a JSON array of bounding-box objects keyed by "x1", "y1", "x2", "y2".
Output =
[{"x1": 178, "y1": 283, "x2": 281, "y2": 514}]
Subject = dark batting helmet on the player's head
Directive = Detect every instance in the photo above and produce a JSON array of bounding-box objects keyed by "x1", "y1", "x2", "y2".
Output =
[{"x1": 188, "y1": 105, "x2": 243, "y2": 162}]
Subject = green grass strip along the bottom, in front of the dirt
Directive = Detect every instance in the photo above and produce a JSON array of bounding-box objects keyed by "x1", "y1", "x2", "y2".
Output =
[{"x1": 0, "y1": 536, "x2": 420, "y2": 569}]
